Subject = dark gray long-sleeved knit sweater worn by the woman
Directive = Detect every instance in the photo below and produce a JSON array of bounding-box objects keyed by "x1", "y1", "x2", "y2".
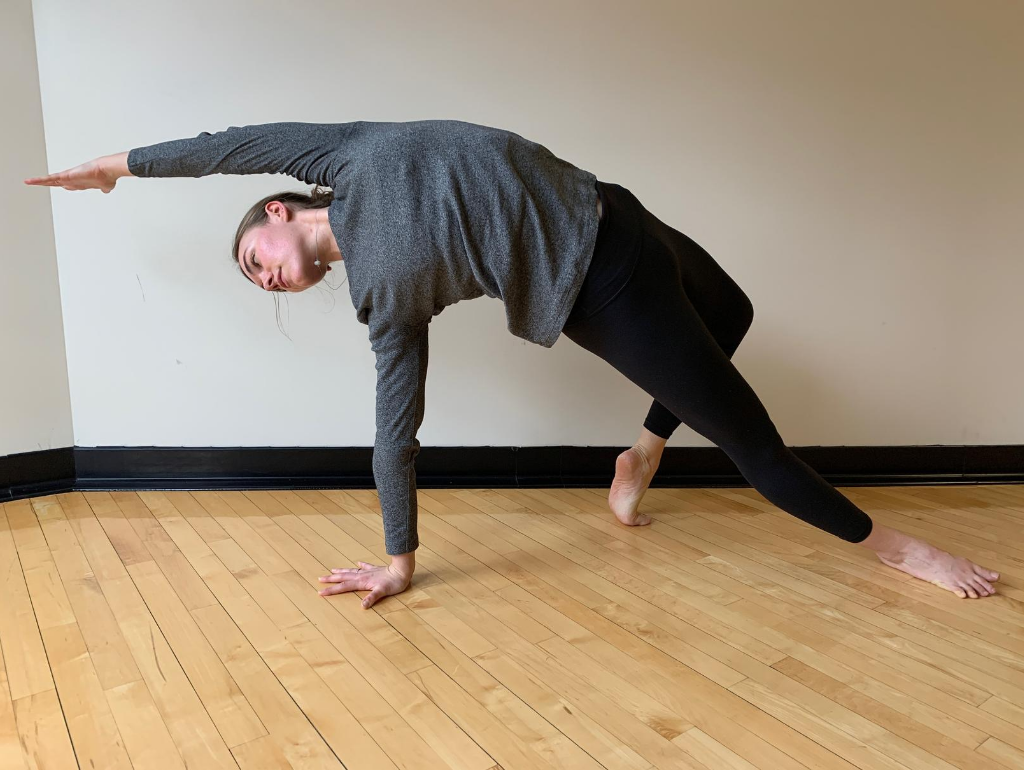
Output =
[{"x1": 128, "y1": 120, "x2": 598, "y2": 555}]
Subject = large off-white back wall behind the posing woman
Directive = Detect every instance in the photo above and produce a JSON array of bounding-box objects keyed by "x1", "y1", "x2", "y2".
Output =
[{"x1": 25, "y1": 0, "x2": 1024, "y2": 446}]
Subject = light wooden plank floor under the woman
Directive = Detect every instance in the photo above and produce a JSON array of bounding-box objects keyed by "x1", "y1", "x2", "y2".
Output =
[{"x1": 0, "y1": 485, "x2": 1024, "y2": 770}]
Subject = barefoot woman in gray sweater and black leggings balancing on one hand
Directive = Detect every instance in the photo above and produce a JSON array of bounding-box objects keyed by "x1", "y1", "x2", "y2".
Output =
[{"x1": 26, "y1": 120, "x2": 998, "y2": 607}]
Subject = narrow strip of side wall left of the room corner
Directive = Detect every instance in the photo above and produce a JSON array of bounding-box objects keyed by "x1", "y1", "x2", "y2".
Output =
[{"x1": 0, "y1": 0, "x2": 75, "y2": 457}]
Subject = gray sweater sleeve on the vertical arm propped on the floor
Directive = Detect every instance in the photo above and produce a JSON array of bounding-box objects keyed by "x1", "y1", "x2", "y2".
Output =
[{"x1": 370, "y1": 319, "x2": 430, "y2": 556}]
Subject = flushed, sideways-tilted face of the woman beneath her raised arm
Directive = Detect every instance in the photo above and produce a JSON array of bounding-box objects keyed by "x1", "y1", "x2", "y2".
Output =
[{"x1": 238, "y1": 201, "x2": 329, "y2": 292}]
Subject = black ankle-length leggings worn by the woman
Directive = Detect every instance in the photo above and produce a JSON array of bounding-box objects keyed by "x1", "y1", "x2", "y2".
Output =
[{"x1": 562, "y1": 181, "x2": 871, "y2": 543}]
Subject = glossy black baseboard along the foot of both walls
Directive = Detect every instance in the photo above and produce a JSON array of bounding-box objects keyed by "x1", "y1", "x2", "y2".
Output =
[{"x1": 0, "y1": 444, "x2": 1024, "y2": 502}]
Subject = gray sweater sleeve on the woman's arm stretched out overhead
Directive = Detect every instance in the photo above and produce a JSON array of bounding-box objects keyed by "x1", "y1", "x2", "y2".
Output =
[{"x1": 128, "y1": 122, "x2": 360, "y2": 186}]
